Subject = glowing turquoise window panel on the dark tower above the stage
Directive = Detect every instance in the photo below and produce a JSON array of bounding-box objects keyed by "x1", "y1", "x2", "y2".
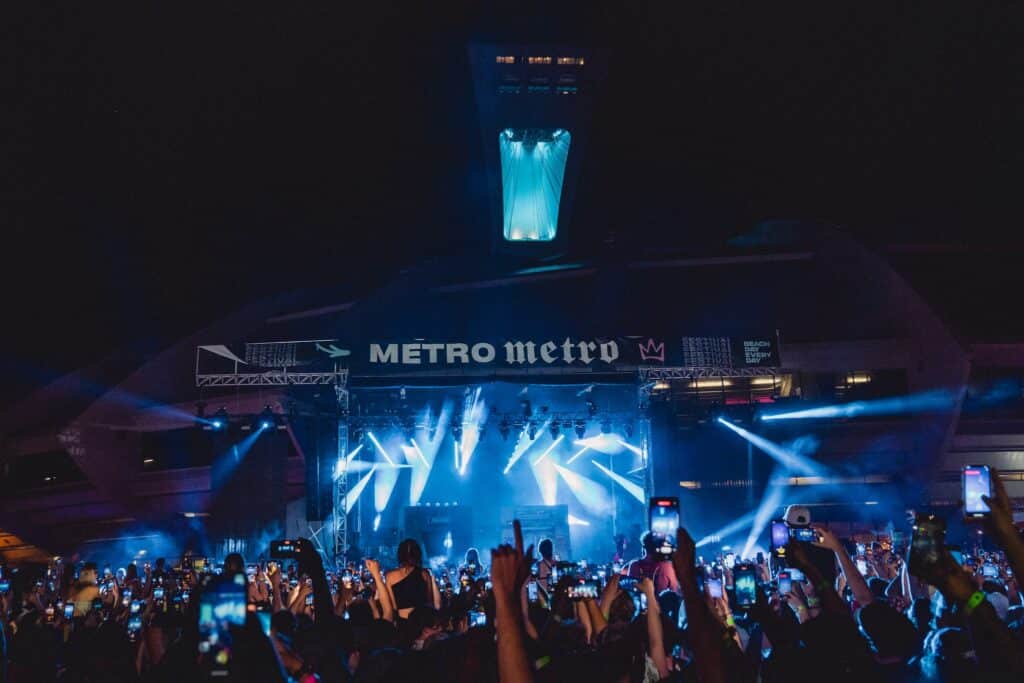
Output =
[{"x1": 498, "y1": 128, "x2": 571, "y2": 242}]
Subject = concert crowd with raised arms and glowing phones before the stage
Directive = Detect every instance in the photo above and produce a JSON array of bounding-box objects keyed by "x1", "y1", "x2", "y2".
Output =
[{"x1": 0, "y1": 466, "x2": 1024, "y2": 683}]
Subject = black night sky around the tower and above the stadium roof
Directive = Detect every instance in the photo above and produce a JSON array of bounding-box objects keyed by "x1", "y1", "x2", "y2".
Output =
[{"x1": 0, "y1": 0, "x2": 1024, "y2": 405}]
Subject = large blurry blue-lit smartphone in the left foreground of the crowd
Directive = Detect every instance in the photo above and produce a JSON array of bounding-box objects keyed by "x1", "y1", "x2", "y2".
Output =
[{"x1": 199, "y1": 581, "x2": 246, "y2": 678}]
